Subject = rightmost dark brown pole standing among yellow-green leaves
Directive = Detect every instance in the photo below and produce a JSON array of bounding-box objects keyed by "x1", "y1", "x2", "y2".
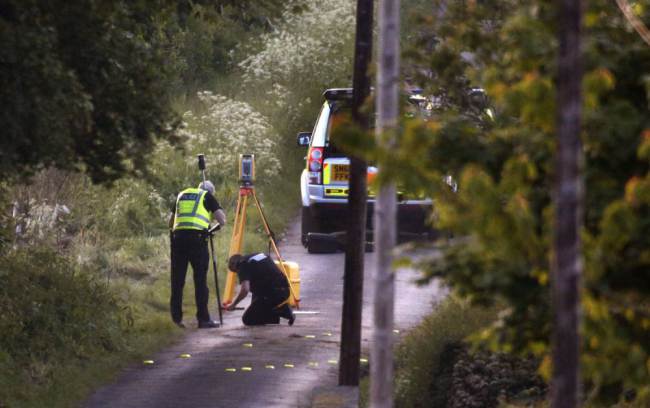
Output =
[{"x1": 551, "y1": 0, "x2": 582, "y2": 408}]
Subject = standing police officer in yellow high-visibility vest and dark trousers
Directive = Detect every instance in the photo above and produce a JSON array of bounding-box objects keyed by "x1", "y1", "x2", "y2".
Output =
[{"x1": 169, "y1": 180, "x2": 226, "y2": 329}]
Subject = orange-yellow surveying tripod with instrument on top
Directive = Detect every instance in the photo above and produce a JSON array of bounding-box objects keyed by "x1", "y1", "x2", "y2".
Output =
[{"x1": 223, "y1": 155, "x2": 300, "y2": 308}]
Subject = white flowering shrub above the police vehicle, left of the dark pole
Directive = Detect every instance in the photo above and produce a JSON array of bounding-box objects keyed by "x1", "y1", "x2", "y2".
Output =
[{"x1": 238, "y1": 0, "x2": 355, "y2": 128}]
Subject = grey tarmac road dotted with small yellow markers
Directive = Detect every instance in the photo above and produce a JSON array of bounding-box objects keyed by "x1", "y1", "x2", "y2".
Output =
[{"x1": 83, "y1": 221, "x2": 445, "y2": 408}]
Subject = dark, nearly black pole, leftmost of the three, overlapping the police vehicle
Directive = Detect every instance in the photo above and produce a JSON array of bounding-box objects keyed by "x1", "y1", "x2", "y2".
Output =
[{"x1": 339, "y1": 0, "x2": 373, "y2": 386}]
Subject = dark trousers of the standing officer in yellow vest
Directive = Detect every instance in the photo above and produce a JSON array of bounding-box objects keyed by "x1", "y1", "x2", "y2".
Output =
[{"x1": 169, "y1": 230, "x2": 210, "y2": 322}]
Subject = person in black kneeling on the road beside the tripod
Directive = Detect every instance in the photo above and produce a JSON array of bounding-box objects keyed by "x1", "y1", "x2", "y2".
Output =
[{"x1": 226, "y1": 253, "x2": 296, "y2": 326}]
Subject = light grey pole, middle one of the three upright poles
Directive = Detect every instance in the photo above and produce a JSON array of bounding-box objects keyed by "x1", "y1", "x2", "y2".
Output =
[{"x1": 370, "y1": 0, "x2": 400, "y2": 408}]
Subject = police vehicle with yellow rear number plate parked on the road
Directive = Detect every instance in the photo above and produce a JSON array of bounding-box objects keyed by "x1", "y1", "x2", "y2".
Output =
[{"x1": 297, "y1": 88, "x2": 434, "y2": 249}]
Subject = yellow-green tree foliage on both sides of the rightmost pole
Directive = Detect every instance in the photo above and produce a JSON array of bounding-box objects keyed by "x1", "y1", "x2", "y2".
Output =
[{"x1": 382, "y1": 0, "x2": 650, "y2": 402}]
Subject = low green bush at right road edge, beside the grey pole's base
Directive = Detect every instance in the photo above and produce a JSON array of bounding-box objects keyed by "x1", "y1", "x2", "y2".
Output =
[{"x1": 395, "y1": 296, "x2": 545, "y2": 407}]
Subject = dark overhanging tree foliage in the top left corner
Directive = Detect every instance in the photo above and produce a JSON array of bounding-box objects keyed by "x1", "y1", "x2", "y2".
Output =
[{"x1": 0, "y1": 0, "x2": 182, "y2": 182}]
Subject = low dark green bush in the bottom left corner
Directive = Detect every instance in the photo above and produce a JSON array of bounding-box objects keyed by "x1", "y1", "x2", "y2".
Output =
[{"x1": 0, "y1": 248, "x2": 129, "y2": 401}]
